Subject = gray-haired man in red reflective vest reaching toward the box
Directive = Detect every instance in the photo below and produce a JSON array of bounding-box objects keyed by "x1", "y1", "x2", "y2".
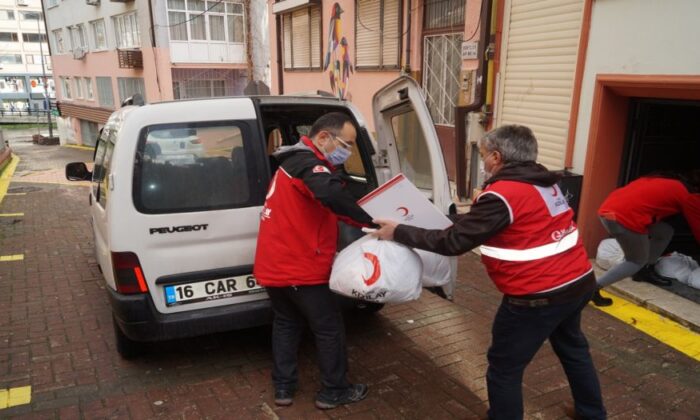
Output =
[{"x1": 373, "y1": 125, "x2": 606, "y2": 419}]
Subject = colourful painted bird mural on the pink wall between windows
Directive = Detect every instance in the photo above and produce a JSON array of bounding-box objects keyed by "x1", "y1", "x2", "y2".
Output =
[{"x1": 323, "y1": 3, "x2": 354, "y2": 100}]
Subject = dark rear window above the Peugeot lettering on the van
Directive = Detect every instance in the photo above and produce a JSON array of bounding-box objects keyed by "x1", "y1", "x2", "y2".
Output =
[{"x1": 134, "y1": 123, "x2": 258, "y2": 213}]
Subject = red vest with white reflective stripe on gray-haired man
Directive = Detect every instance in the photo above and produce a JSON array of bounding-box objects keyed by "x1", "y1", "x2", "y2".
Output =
[{"x1": 477, "y1": 181, "x2": 592, "y2": 296}]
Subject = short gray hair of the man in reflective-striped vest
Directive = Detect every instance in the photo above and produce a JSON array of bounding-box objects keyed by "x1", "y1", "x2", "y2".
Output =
[{"x1": 479, "y1": 124, "x2": 537, "y2": 163}]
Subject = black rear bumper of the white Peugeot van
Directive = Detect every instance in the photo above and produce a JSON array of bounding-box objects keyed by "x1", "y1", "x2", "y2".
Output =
[{"x1": 108, "y1": 289, "x2": 272, "y2": 341}]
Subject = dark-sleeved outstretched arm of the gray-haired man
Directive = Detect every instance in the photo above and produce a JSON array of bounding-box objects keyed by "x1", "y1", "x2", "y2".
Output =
[{"x1": 388, "y1": 194, "x2": 511, "y2": 255}]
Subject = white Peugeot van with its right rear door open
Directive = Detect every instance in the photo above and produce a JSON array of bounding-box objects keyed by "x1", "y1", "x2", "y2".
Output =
[{"x1": 66, "y1": 77, "x2": 456, "y2": 357}]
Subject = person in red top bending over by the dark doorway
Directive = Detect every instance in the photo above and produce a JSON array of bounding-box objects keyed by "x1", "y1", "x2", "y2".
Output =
[{"x1": 593, "y1": 170, "x2": 700, "y2": 306}]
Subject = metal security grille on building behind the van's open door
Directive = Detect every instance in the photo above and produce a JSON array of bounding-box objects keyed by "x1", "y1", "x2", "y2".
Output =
[{"x1": 423, "y1": 33, "x2": 462, "y2": 125}]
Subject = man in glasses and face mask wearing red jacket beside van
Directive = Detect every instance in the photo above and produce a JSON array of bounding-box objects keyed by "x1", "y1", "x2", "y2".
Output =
[{"x1": 253, "y1": 112, "x2": 371, "y2": 409}]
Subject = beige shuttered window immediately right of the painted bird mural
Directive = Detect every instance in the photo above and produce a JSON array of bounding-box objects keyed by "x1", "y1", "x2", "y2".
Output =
[{"x1": 355, "y1": 0, "x2": 401, "y2": 69}]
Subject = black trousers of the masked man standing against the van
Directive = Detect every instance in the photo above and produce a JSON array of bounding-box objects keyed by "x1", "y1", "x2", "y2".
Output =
[{"x1": 267, "y1": 284, "x2": 350, "y2": 397}]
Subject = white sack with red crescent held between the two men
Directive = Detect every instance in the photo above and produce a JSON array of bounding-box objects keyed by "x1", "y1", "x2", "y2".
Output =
[{"x1": 330, "y1": 235, "x2": 423, "y2": 303}]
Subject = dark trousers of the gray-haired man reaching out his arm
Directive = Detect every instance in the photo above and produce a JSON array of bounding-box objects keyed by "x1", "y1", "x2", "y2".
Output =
[{"x1": 486, "y1": 293, "x2": 606, "y2": 420}]
